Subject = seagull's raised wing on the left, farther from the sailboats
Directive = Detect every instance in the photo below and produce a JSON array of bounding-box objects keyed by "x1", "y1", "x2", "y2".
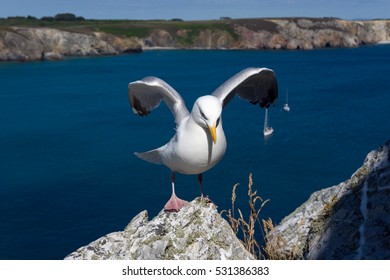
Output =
[{"x1": 128, "y1": 77, "x2": 189, "y2": 124}]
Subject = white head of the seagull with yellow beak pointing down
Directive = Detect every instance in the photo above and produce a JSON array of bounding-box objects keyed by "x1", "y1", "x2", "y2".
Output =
[{"x1": 191, "y1": 95, "x2": 222, "y2": 144}]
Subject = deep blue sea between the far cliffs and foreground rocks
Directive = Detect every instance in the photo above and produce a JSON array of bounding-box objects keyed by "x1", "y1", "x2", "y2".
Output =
[{"x1": 0, "y1": 45, "x2": 390, "y2": 259}]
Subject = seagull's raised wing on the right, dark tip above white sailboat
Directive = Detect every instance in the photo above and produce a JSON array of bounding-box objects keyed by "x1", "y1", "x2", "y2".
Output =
[{"x1": 213, "y1": 68, "x2": 278, "y2": 108}]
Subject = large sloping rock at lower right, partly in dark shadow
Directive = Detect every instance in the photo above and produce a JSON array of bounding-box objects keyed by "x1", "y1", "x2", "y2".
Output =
[{"x1": 268, "y1": 141, "x2": 390, "y2": 259}]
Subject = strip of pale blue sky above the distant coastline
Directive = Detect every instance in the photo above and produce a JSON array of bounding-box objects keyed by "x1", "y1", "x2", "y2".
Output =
[{"x1": 0, "y1": 0, "x2": 390, "y2": 20}]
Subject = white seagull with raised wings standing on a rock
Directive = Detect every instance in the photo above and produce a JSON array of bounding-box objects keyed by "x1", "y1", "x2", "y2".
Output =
[{"x1": 128, "y1": 68, "x2": 278, "y2": 212}]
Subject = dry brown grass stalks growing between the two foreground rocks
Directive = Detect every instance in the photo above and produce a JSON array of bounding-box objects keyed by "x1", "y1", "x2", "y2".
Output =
[{"x1": 221, "y1": 174, "x2": 296, "y2": 260}]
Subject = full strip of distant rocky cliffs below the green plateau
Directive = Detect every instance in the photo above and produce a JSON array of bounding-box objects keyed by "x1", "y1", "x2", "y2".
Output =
[{"x1": 0, "y1": 18, "x2": 390, "y2": 61}]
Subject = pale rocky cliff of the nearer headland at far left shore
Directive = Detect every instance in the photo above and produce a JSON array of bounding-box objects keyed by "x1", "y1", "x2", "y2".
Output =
[{"x1": 0, "y1": 27, "x2": 141, "y2": 61}]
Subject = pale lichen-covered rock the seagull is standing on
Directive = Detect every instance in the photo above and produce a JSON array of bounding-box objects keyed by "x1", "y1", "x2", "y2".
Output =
[{"x1": 65, "y1": 198, "x2": 254, "y2": 260}]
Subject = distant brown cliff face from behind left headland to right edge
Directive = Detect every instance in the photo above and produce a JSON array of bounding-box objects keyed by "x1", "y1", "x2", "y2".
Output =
[{"x1": 138, "y1": 18, "x2": 390, "y2": 50}]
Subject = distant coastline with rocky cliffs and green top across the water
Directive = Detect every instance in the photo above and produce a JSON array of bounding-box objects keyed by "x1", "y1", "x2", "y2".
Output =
[{"x1": 0, "y1": 17, "x2": 390, "y2": 61}]
